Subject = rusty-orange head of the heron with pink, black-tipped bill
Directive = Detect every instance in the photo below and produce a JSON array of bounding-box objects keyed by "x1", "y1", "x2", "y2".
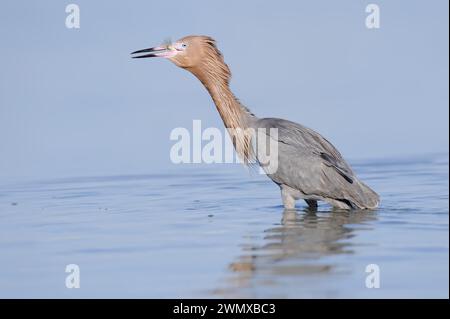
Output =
[{"x1": 131, "y1": 35, "x2": 230, "y2": 82}]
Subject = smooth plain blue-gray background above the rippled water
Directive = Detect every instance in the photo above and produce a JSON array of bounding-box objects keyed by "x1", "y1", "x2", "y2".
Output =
[{"x1": 0, "y1": 0, "x2": 449, "y2": 180}]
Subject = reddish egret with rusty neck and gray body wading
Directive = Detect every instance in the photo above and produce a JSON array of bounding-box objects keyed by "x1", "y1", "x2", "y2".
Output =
[{"x1": 131, "y1": 35, "x2": 380, "y2": 210}]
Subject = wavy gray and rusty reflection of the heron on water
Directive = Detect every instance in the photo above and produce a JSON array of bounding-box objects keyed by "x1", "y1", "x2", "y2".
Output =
[{"x1": 217, "y1": 209, "x2": 376, "y2": 295}]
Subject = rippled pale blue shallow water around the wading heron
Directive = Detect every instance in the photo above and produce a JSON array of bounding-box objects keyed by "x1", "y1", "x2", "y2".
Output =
[{"x1": 0, "y1": 154, "x2": 449, "y2": 298}]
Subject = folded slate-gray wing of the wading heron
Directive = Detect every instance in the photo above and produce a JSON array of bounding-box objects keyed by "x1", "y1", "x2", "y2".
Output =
[{"x1": 255, "y1": 118, "x2": 378, "y2": 207}]
